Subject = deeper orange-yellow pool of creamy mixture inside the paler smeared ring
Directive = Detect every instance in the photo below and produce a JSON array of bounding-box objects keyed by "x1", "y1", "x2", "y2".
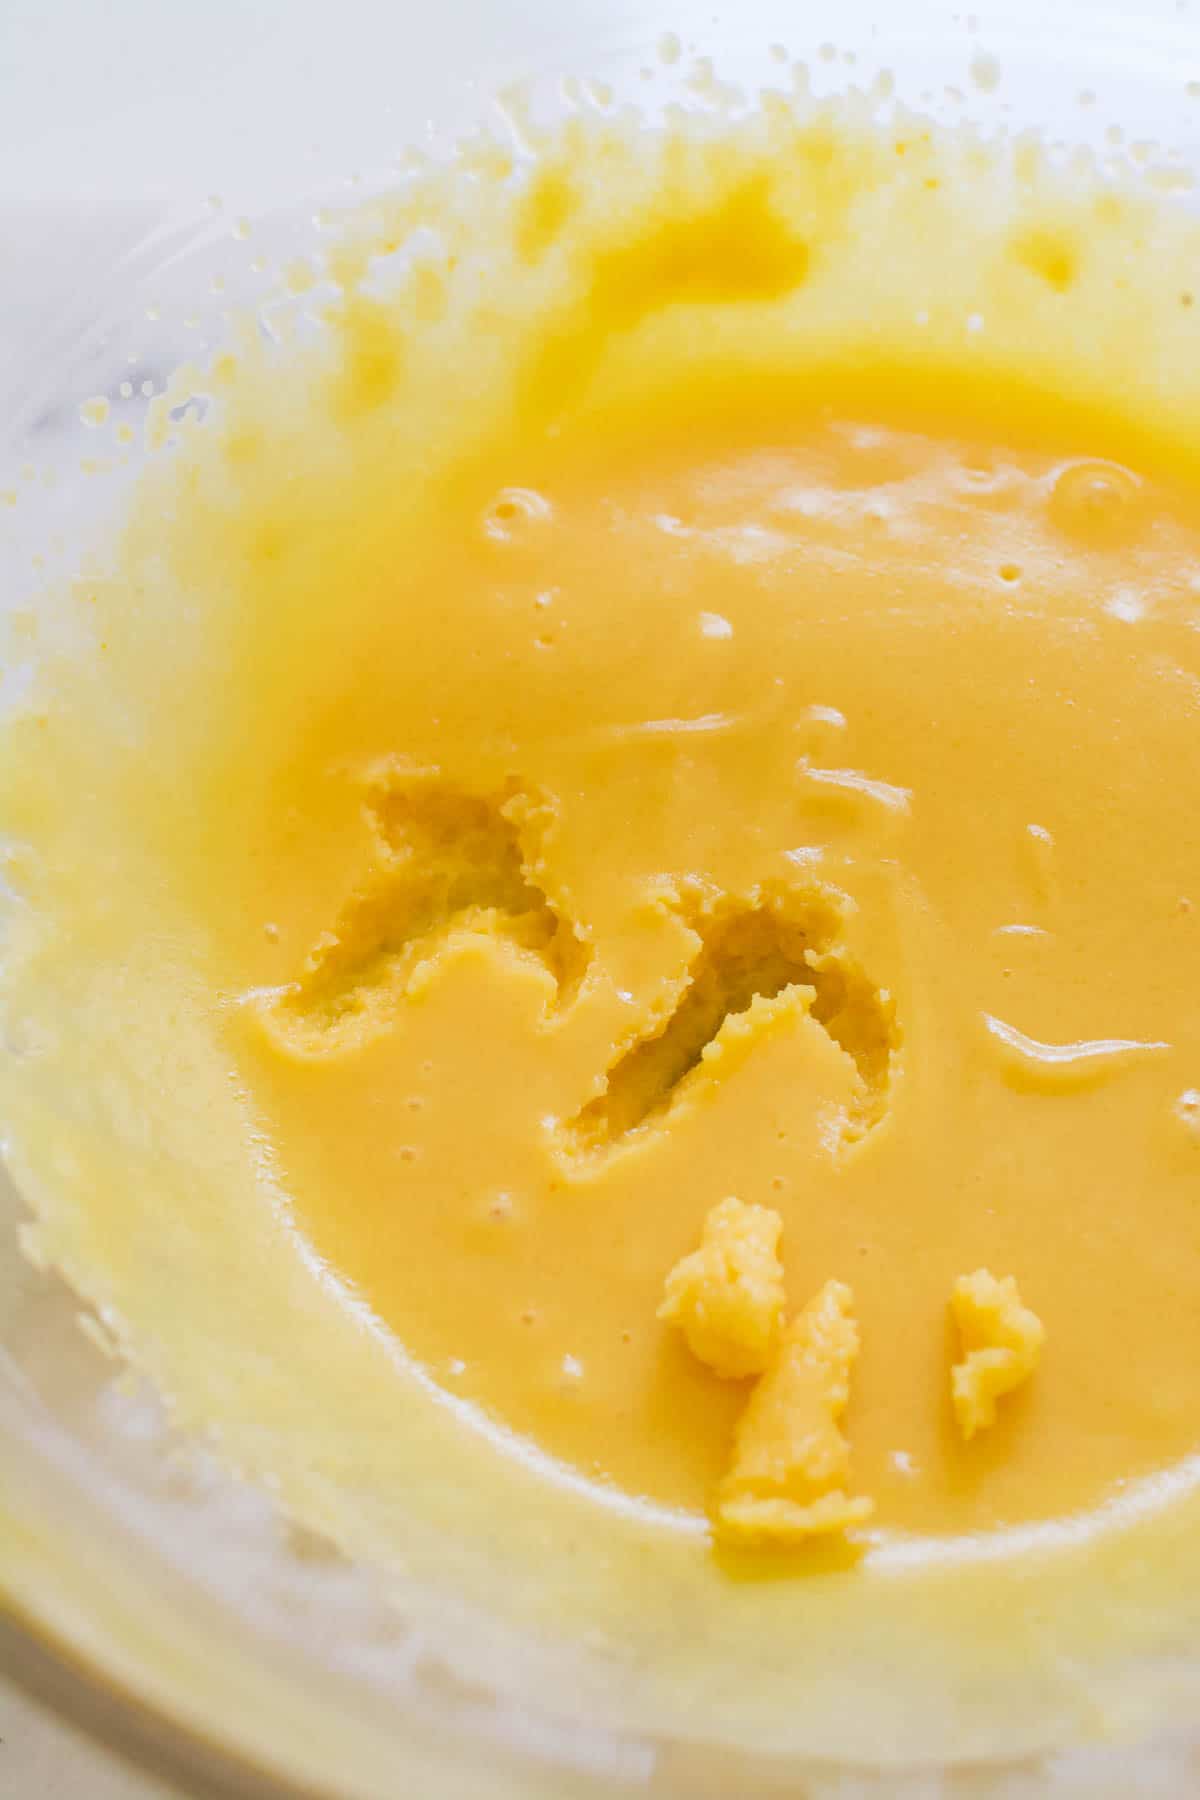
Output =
[{"x1": 225, "y1": 397, "x2": 1200, "y2": 1532}]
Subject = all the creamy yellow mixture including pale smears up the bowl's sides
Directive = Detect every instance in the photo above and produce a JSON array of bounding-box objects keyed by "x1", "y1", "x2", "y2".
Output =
[{"x1": 5, "y1": 81, "x2": 1200, "y2": 1753}]
